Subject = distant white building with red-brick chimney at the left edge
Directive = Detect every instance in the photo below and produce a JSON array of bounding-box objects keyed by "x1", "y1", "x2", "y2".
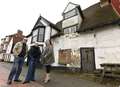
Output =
[{"x1": 0, "y1": 30, "x2": 25, "y2": 62}]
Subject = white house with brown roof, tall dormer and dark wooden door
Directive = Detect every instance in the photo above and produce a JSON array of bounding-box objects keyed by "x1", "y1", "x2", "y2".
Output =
[{"x1": 51, "y1": 0, "x2": 120, "y2": 72}]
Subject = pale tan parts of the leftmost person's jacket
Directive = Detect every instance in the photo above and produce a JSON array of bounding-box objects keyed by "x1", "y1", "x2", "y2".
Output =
[{"x1": 13, "y1": 42, "x2": 28, "y2": 57}]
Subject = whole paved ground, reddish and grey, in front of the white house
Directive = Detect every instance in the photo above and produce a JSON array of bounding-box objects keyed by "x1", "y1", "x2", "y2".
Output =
[{"x1": 0, "y1": 62, "x2": 110, "y2": 87}]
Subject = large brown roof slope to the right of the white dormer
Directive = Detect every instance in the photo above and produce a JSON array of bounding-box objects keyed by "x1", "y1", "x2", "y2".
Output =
[{"x1": 78, "y1": 3, "x2": 120, "y2": 32}]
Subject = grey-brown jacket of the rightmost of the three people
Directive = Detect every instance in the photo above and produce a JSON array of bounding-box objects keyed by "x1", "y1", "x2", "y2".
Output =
[{"x1": 42, "y1": 46, "x2": 55, "y2": 65}]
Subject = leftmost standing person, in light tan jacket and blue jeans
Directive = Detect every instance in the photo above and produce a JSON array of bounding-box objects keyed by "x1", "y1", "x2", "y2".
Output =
[{"x1": 7, "y1": 38, "x2": 28, "y2": 84}]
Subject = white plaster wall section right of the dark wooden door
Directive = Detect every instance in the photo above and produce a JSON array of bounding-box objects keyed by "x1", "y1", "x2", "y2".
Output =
[{"x1": 95, "y1": 26, "x2": 120, "y2": 68}]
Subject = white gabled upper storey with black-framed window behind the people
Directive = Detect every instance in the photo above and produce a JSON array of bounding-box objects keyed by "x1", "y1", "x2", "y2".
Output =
[{"x1": 27, "y1": 16, "x2": 60, "y2": 51}]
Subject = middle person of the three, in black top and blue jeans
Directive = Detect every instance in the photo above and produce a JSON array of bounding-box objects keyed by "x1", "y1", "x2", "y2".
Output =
[{"x1": 23, "y1": 43, "x2": 41, "y2": 84}]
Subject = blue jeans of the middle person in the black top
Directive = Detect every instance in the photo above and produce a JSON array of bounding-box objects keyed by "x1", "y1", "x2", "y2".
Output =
[{"x1": 25, "y1": 57, "x2": 37, "y2": 81}]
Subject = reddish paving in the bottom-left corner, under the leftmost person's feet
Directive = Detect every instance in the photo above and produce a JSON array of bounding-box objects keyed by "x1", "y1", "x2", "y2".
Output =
[{"x1": 0, "y1": 63, "x2": 44, "y2": 87}]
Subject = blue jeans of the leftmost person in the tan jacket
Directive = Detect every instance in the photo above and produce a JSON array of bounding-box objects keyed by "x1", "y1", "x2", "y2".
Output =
[{"x1": 8, "y1": 57, "x2": 24, "y2": 80}]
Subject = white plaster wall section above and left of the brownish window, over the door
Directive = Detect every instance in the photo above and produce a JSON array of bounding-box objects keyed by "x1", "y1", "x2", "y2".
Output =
[{"x1": 54, "y1": 33, "x2": 95, "y2": 65}]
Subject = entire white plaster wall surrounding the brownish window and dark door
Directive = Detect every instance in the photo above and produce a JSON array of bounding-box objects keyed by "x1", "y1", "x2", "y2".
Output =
[{"x1": 54, "y1": 26, "x2": 120, "y2": 69}]
